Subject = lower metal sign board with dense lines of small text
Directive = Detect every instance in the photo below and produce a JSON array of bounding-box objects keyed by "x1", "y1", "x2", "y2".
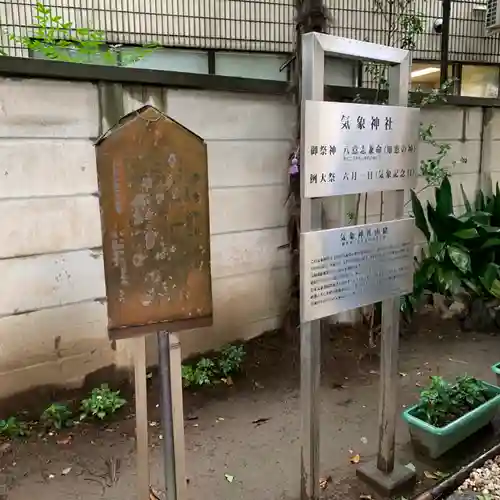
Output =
[{"x1": 301, "y1": 218, "x2": 414, "y2": 322}]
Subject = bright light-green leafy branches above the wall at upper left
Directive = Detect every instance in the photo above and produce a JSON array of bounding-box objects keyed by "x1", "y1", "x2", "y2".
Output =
[{"x1": 3, "y1": 2, "x2": 157, "y2": 66}]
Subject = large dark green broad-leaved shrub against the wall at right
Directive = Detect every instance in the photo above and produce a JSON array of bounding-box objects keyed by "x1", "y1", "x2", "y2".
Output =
[{"x1": 402, "y1": 176, "x2": 500, "y2": 315}]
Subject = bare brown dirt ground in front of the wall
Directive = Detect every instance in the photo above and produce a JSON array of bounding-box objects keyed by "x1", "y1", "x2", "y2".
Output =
[{"x1": 0, "y1": 318, "x2": 500, "y2": 500}]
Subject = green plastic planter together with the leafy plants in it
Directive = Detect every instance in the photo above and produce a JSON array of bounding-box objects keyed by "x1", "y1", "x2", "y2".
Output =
[{"x1": 403, "y1": 375, "x2": 500, "y2": 458}]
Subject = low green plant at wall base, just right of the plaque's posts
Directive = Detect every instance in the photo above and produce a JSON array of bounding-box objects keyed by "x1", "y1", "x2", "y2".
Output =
[{"x1": 182, "y1": 345, "x2": 245, "y2": 387}]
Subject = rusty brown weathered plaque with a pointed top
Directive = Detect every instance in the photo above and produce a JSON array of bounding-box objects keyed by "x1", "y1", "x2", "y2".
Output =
[{"x1": 96, "y1": 106, "x2": 212, "y2": 338}]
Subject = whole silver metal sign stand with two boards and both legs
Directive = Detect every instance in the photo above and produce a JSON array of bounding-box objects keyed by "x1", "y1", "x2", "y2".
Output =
[{"x1": 300, "y1": 33, "x2": 419, "y2": 500}]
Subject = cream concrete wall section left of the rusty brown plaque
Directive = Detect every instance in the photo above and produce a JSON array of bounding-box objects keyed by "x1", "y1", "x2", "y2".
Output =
[{"x1": 0, "y1": 79, "x2": 114, "y2": 396}]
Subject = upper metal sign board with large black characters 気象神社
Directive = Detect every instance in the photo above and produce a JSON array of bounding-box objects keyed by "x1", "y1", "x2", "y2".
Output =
[{"x1": 301, "y1": 101, "x2": 420, "y2": 198}]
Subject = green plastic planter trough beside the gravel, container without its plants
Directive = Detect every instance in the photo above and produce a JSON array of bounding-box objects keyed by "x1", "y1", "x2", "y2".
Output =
[{"x1": 403, "y1": 382, "x2": 500, "y2": 458}]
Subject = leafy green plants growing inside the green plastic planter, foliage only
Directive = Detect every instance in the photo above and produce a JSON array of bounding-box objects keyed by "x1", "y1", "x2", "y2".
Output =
[{"x1": 416, "y1": 375, "x2": 490, "y2": 427}]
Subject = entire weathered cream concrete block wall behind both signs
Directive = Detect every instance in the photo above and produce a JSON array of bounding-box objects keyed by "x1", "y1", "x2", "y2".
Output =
[{"x1": 0, "y1": 75, "x2": 494, "y2": 399}]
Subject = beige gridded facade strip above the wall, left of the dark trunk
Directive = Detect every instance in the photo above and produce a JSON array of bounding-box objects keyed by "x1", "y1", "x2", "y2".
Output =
[{"x1": 0, "y1": 0, "x2": 295, "y2": 56}]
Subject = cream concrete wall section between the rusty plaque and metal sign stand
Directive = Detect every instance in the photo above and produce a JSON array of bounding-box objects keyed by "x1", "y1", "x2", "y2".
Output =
[{"x1": 166, "y1": 90, "x2": 295, "y2": 354}]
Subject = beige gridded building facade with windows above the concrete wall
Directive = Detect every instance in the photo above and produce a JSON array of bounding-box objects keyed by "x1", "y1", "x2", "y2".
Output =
[{"x1": 0, "y1": 0, "x2": 500, "y2": 98}]
